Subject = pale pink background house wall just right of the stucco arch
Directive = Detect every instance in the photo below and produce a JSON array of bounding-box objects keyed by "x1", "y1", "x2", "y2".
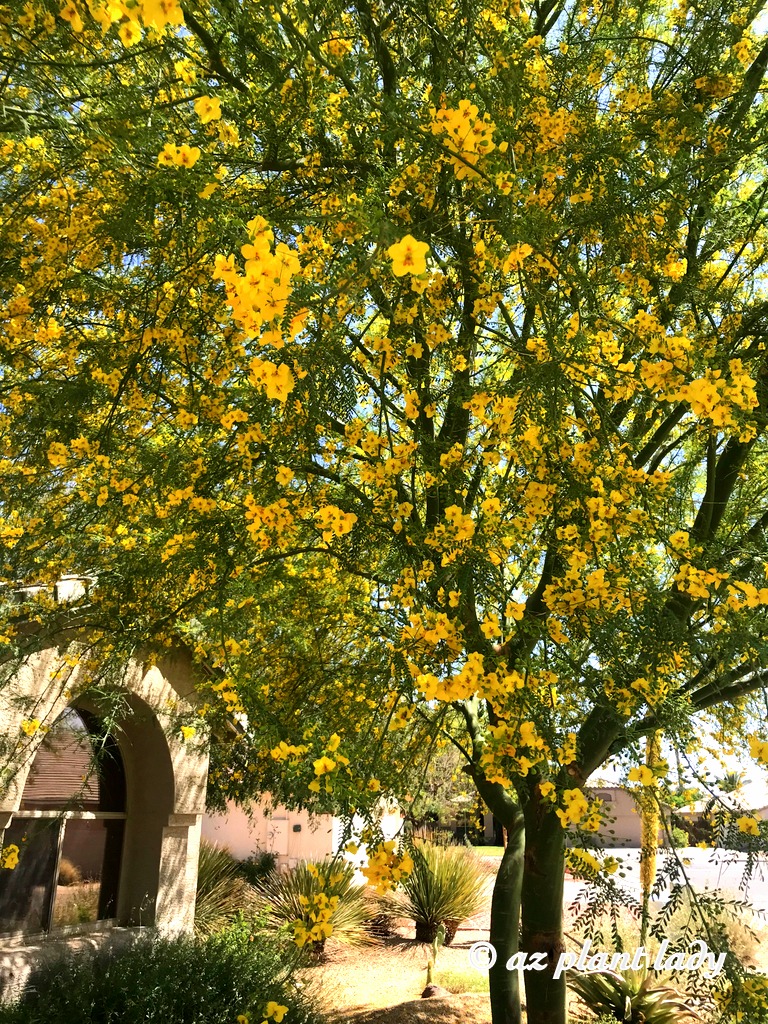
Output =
[{"x1": 203, "y1": 803, "x2": 402, "y2": 868}]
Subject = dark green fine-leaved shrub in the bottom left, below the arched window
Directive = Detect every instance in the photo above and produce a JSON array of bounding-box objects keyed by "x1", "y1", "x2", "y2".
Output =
[{"x1": 0, "y1": 922, "x2": 322, "y2": 1024}]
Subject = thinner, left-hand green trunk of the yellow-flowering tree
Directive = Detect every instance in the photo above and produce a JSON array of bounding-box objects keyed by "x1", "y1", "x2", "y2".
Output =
[{"x1": 488, "y1": 814, "x2": 525, "y2": 1024}]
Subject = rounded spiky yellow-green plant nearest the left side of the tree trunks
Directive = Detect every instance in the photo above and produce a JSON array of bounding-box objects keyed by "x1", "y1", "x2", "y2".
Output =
[{"x1": 380, "y1": 843, "x2": 487, "y2": 945}]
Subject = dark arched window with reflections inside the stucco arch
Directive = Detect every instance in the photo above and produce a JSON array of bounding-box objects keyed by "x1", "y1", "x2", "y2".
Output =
[{"x1": 0, "y1": 707, "x2": 126, "y2": 934}]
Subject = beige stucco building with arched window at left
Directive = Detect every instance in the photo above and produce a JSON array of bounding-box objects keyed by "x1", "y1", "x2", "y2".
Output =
[{"x1": 0, "y1": 602, "x2": 208, "y2": 990}]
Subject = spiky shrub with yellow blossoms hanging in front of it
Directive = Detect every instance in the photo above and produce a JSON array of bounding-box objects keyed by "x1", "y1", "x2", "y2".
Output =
[{"x1": 254, "y1": 857, "x2": 374, "y2": 950}]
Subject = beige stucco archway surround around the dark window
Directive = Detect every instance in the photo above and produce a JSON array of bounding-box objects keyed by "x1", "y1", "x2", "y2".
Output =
[{"x1": 0, "y1": 641, "x2": 208, "y2": 934}]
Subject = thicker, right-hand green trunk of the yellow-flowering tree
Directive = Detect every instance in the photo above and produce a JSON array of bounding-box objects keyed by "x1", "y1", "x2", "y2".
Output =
[{"x1": 521, "y1": 788, "x2": 567, "y2": 1024}]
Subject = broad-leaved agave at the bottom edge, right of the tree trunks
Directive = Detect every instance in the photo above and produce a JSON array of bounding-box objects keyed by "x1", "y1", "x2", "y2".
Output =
[{"x1": 568, "y1": 970, "x2": 700, "y2": 1024}]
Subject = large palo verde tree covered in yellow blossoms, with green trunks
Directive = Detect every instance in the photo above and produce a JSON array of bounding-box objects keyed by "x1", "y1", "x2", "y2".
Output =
[{"x1": 0, "y1": 0, "x2": 768, "y2": 1024}]
